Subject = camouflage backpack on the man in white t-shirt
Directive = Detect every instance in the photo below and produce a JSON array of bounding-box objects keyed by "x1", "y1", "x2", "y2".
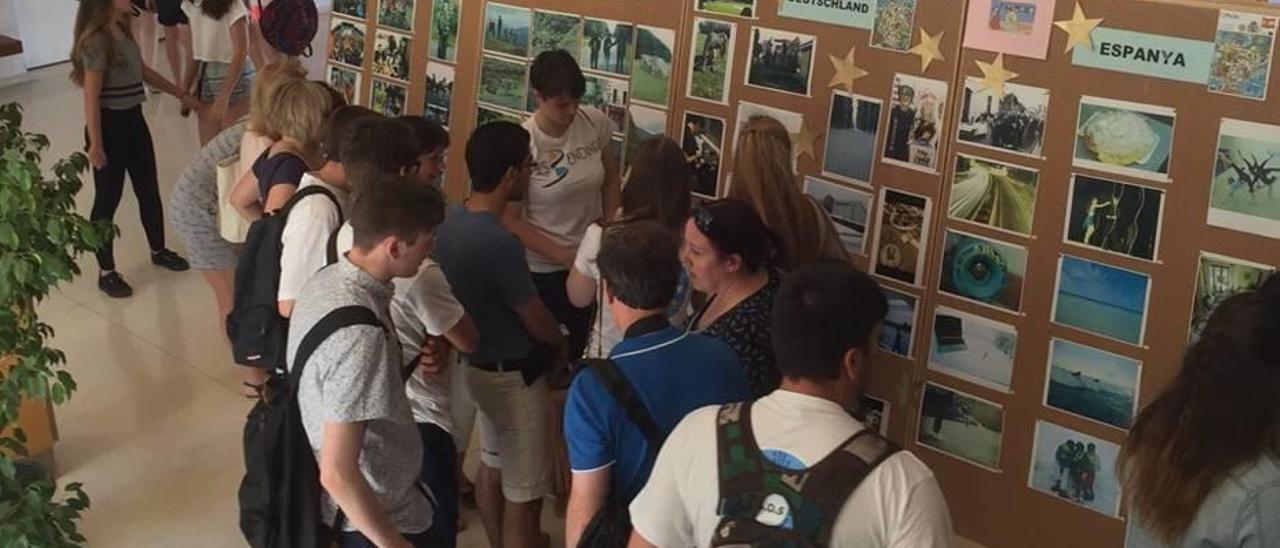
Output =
[{"x1": 710, "y1": 402, "x2": 899, "y2": 548}]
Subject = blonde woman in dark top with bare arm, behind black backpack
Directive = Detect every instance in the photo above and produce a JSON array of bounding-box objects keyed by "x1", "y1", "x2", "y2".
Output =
[{"x1": 230, "y1": 79, "x2": 340, "y2": 220}]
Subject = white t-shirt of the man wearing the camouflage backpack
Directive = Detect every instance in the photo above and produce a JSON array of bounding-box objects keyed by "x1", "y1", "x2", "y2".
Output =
[{"x1": 631, "y1": 389, "x2": 951, "y2": 548}]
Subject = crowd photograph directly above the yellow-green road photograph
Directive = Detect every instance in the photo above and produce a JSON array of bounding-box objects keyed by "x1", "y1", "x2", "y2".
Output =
[{"x1": 959, "y1": 77, "x2": 1048, "y2": 157}]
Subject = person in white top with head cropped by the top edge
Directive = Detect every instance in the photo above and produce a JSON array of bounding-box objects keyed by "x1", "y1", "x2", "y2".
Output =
[{"x1": 182, "y1": 0, "x2": 253, "y2": 145}]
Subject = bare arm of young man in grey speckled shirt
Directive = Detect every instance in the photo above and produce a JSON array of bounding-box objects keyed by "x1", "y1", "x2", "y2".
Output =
[{"x1": 320, "y1": 423, "x2": 411, "y2": 548}]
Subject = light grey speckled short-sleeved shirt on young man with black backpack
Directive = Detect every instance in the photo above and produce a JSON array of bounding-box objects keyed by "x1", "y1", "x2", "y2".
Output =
[{"x1": 288, "y1": 256, "x2": 433, "y2": 534}]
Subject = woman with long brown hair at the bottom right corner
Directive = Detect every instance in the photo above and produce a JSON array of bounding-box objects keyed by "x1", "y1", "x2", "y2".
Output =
[{"x1": 1116, "y1": 286, "x2": 1280, "y2": 548}]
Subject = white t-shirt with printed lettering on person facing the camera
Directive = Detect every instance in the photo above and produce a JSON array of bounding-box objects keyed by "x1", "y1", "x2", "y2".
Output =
[{"x1": 525, "y1": 106, "x2": 613, "y2": 273}]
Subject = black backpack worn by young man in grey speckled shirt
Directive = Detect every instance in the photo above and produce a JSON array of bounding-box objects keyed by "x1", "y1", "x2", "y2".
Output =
[{"x1": 239, "y1": 306, "x2": 387, "y2": 548}]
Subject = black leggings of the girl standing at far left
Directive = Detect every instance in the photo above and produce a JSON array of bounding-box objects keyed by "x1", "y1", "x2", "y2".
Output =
[{"x1": 86, "y1": 106, "x2": 164, "y2": 270}]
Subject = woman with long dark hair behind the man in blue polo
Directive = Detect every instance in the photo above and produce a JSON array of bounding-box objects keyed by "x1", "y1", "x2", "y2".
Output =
[{"x1": 567, "y1": 137, "x2": 691, "y2": 357}]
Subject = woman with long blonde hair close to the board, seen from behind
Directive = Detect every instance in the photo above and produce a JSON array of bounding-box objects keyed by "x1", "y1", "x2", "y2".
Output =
[{"x1": 728, "y1": 115, "x2": 849, "y2": 271}]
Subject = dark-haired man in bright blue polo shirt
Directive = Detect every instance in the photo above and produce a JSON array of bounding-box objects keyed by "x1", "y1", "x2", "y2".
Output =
[{"x1": 564, "y1": 220, "x2": 750, "y2": 545}]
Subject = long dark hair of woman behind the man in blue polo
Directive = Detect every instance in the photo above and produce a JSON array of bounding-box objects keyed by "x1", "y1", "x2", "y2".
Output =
[{"x1": 622, "y1": 137, "x2": 692, "y2": 234}]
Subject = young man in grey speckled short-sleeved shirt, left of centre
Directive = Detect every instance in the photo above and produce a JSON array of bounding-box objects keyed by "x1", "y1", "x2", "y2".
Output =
[{"x1": 288, "y1": 177, "x2": 444, "y2": 548}]
